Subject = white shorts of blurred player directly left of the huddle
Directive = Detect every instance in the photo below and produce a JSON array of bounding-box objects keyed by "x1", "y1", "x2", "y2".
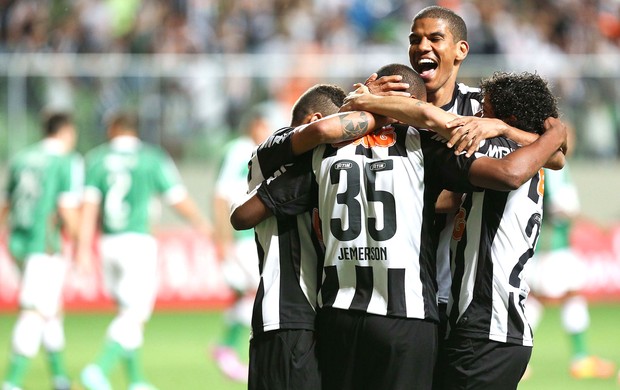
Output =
[{"x1": 222, "y1": 239, "x2": 260, "y2": 292}]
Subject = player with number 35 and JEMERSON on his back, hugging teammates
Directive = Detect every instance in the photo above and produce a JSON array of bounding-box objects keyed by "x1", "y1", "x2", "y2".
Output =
[{"x1": 249, "y1": 65, "x2": 563, "y2": 389}]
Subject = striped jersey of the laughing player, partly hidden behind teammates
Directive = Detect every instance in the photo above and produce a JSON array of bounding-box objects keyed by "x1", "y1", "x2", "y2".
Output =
[{"x1": 436, "y1": 83, "x2": 482, "y2": 303}]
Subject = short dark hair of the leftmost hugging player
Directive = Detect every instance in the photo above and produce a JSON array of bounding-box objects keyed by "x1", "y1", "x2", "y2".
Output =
[{"x1": 291, "y1": 84, "x2": 346, "y2": 126}]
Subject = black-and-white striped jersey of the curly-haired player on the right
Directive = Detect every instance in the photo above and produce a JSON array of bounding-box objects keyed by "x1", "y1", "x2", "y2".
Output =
[{"x1": 448, "y1": 137, "x2": 543, "y2": 346}]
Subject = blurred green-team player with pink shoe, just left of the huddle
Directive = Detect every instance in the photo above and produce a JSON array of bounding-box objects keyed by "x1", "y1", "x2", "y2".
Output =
[{"x1": 213, "y1": 105, "x2": 274, "y2": 382}]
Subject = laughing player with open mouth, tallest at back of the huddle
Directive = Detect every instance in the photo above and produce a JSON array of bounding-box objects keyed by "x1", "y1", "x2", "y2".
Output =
[{"x1": 365, "y1": 9, "x2": 560, "y2": 386}]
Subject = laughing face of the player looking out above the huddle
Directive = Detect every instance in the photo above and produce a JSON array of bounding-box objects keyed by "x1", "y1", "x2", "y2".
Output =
[{"x1": 409, "y1": 17, "x2": 469, "y2": 106}]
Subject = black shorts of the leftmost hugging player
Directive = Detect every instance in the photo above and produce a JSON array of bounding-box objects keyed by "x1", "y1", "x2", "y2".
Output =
[{"x1": 248, "y1": 329, "x2": 321, "y2": 390}]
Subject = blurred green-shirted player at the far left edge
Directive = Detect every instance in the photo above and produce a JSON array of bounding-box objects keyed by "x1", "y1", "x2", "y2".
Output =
[{"x1": 2, "y1": 113, "x2": 83, "y2": 390}]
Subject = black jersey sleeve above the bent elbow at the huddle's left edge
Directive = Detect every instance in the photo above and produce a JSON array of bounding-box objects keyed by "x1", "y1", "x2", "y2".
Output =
[{"x1": 256, "y1": 152, "x2": 318, "y2": 218}]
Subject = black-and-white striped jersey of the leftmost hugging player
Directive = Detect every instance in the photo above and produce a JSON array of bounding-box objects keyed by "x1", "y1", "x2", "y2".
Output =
[{"x1": 248, "y1": 127, "x2": 323, "y2": 335}]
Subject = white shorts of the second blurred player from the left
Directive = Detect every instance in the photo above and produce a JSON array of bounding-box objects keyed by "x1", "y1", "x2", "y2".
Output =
[{"x1": 99, "y1": 233, "x2": 159, "y2": 321}]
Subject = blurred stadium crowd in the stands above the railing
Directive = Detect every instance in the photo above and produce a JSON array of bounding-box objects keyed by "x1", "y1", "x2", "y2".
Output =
[{"x1": 0, "y1": 0, "x2": 620, "y2": 54}]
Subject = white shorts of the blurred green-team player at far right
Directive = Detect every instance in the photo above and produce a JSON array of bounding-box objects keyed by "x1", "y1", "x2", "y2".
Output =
[{"x1": 526, "y1": 248, "x2": 587, "y2": 298}]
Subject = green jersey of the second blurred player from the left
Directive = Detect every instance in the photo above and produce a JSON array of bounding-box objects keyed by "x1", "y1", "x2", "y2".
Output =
[{"x1": 85, "y1": 136, "x2": 187, "y2": 234}]
